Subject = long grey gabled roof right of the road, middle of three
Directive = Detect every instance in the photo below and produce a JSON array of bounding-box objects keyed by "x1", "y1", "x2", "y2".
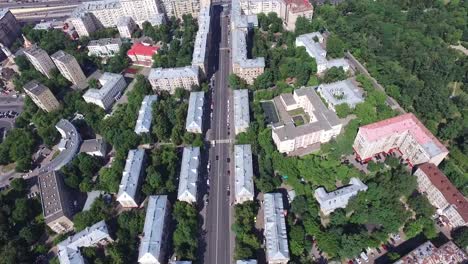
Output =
[{"x1": 234, "y1": 145, "x2": 254, "y2": 200}]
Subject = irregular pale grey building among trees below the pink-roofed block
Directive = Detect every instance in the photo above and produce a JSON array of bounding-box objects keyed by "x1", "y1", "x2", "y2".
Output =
[{"x1": 314, "y1": 178, "x2": 367, "y2": 215}]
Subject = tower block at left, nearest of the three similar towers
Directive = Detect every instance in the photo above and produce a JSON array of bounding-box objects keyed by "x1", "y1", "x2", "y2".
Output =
[{"x1": 23, "y1": 80, "x2": 60, "y2": 112}]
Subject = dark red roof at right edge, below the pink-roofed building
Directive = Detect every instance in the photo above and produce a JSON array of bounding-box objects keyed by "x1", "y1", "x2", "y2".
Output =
[{"x1": 419, "y1": 163, "x2": 468, "y2": 222}]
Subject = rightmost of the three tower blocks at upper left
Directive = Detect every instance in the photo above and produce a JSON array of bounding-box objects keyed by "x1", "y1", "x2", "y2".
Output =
[{"x1": 51, "y1": 50, "x2": 86, "y2": 84}]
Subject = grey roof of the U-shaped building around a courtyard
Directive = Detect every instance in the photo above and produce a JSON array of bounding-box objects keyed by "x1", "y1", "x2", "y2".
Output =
[{"x1": 273, "y1": 87, "x2": 341, "y2": 140}]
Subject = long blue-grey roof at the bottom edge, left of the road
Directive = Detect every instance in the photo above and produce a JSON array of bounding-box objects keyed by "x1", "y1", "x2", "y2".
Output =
[{"x1": 138, "y1": 195, "x2": 168, "y2": 263}]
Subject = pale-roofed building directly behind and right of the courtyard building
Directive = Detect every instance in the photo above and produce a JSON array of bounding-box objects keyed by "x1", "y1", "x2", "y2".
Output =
[{"x1": 317, "y1": 79, "x2": 364, "y2": 111}]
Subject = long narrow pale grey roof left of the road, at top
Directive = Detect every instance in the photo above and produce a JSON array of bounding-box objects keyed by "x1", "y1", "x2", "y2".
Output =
[{"x1": 192, "y1": 6, "x2": 210, "y2": 68}]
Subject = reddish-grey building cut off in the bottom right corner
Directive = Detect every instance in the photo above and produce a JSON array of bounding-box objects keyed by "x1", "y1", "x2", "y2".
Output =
[{"x1": 395, "y1": 241, "x2": 468, "y2": 264}]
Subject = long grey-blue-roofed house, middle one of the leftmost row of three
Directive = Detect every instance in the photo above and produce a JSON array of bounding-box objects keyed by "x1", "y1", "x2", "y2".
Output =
[{"x1": 116, "y1": 149, "x2": 145, "y2": 207}]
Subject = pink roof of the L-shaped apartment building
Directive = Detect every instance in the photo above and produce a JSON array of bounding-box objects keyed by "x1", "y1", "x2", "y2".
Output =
[{"x1": 359, "y1": 113, "x2": 448, "y2": 152}]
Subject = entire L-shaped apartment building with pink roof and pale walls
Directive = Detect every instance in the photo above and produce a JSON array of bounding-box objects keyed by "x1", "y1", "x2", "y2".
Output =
[{"x1": 353, "y1": 113, "x2": 449, "y2": 166}]
